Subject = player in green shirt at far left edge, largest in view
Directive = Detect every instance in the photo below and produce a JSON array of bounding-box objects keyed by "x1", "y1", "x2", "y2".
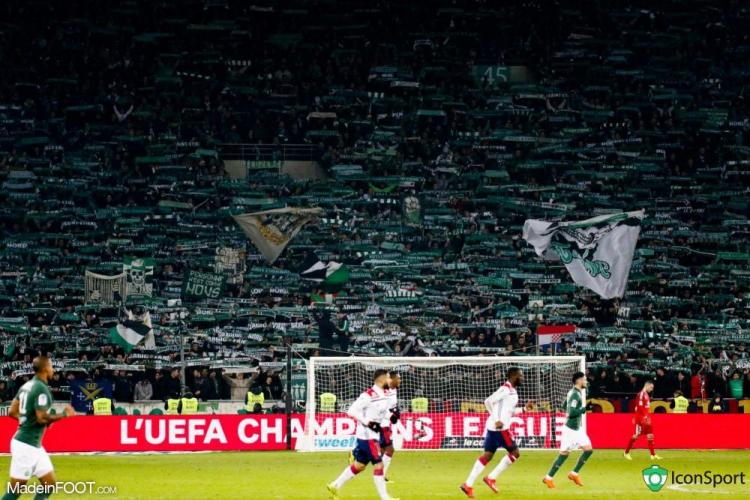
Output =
[{"x1": 2, "y1": 356, "x2": 75, "y2": 500}]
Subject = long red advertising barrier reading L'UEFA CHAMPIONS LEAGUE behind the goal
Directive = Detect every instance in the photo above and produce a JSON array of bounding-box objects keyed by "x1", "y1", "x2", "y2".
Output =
[{"x1": 0, "y1": 413, "x2": 750, "y2": 453}]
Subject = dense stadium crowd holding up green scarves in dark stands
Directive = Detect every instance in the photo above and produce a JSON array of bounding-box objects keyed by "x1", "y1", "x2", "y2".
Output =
[{"x1": 0, "y1": 0, "x2": 750, "y2": 410}]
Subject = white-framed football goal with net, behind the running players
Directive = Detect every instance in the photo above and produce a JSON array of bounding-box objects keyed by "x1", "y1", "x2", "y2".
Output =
[{"x1": 296, "y1": 356, "x2": 585, "y2": 451}]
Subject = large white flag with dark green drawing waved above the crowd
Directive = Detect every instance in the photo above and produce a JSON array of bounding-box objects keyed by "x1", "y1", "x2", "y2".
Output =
[{"x1": 523, "y1": 210, "x2": 644, "y2": 299}]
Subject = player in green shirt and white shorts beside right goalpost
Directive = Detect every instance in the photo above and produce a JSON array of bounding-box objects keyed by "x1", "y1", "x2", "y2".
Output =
[{"x1": 542, "y1": 372, "x2": 594, "y2": 488}]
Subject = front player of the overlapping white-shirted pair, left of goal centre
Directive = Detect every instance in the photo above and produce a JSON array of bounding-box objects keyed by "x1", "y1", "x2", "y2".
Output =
[{"x1": 326, "y1": 370, "x2": 397, "y2": 500}]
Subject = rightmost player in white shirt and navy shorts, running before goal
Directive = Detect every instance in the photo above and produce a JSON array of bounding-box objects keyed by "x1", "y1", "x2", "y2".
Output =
[{"x1": 461, "y1": 367, "x2": 531, "y2": 498}]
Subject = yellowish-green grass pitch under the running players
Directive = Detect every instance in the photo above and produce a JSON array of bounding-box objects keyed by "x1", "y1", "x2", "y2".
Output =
[{"x1": 0, "y1": 450, "x2": 750, "y2": 500}]
